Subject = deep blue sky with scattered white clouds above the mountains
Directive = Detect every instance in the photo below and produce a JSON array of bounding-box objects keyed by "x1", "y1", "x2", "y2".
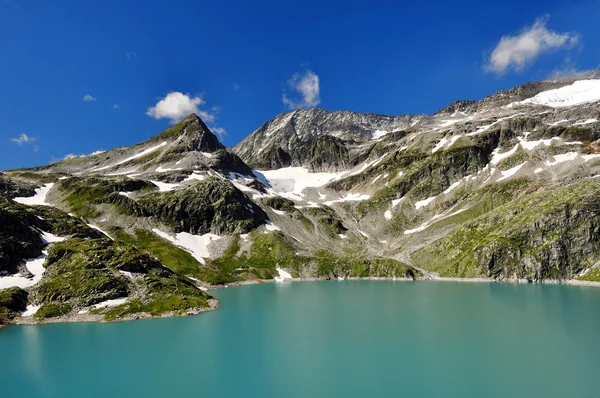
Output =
[{"x1": 0, "y1": 0, "x2": 600, "y2": 169}]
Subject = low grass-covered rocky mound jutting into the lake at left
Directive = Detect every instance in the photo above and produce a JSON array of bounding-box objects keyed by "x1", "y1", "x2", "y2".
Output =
[{"x1": 31, "y1": 239, "x2": 210, "y2": 319}]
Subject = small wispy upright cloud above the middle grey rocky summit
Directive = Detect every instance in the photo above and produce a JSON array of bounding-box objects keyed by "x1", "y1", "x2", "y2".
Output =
[{"x1": 281, "y1": 69, "x2": 321, "y2": 109}]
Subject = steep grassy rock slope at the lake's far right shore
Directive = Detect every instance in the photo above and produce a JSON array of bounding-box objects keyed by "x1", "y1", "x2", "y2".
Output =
[{"x1": 412, "y1": 180, "x2": 600, "y2": 281}]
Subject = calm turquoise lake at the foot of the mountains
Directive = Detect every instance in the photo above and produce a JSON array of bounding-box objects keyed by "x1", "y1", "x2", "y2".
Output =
[{"x1": 0, "y1": 281, "x2": 600, "y2": 398}]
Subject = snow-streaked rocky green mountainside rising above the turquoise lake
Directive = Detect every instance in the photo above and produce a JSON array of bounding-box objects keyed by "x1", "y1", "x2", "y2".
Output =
[{"x1": 0, "y1": 72, "x2": 600, "y2": 321}]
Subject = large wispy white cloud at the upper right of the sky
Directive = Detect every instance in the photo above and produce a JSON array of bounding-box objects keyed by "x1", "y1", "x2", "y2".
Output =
[{"x1": 485, "y1": 17, "x2": 579, "y2": 74}]
